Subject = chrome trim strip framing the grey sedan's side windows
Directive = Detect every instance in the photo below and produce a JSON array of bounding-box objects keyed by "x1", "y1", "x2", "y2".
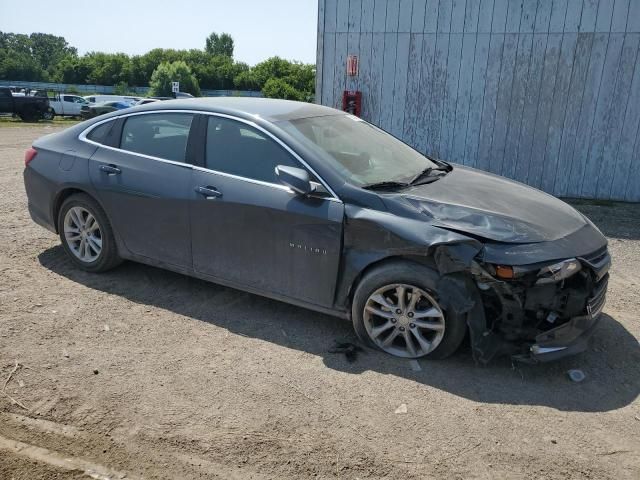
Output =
[{"x1": 78, "y1": 109, "x2": 342, "y2": 203}]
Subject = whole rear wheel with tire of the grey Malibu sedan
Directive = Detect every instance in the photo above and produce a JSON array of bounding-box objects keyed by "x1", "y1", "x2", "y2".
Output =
[{"x1": 58, "y1": 194, "x2": 121, "y2": 272}]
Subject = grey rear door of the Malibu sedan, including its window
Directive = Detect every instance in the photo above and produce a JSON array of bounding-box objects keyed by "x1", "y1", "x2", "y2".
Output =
[{"x1": 89, "y1": 112, "x2": 193, "y2": 268}]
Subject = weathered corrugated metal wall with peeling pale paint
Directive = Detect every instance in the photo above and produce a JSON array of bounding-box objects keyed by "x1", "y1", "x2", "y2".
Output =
[{"x1": 316, "y1": 0, "x2": 640, "y2": 201}]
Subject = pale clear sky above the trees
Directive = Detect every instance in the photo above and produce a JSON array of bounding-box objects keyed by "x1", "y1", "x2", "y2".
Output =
[{"x1": 0, "y1": 0, "x2": 318, "y2": 65}]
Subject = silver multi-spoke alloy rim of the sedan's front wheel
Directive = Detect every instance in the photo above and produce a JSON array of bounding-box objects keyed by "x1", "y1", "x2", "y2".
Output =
[{"x1": 363, "y1": 283, "x2": 445, "y2": 358}]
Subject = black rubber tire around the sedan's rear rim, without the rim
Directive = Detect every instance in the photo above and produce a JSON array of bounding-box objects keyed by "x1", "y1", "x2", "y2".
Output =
[{"x1": 58, "y1": 193, "x2": 122, "y2": 273}]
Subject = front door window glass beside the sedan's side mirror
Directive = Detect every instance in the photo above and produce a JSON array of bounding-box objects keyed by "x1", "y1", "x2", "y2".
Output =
[{"x1": 206, "y1": 116, "x2": 300, "y2": 183}]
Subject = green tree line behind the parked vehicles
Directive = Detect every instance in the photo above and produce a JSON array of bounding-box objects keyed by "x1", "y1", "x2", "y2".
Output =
[{"x1": 0, "y1": 32, "x2": 315, "y2": 101}]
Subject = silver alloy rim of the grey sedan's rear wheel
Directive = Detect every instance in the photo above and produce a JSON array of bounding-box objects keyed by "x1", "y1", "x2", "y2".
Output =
[{"x1": 64, "y1": 207, "x2": 102, "y2": 263}]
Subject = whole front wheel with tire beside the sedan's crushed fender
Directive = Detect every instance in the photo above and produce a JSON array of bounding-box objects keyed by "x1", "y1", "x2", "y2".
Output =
[{"x1": 351, "y1": 261, "x2": 466, "y2": 359}]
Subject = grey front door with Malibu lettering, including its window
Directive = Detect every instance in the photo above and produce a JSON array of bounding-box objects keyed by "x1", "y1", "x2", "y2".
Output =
[{"x1": 190, "y1": 116, "x2": 344, "y2": 306}]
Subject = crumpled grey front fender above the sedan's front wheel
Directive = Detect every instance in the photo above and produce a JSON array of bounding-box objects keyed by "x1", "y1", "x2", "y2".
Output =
[{"x1": 336, "y1": 205, "x2": 504, "y2": 363}]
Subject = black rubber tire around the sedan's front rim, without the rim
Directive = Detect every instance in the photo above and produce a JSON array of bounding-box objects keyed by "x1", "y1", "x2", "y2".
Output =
[{"x1": 351, "y1": 260, "x2": 467, "y2": 359}]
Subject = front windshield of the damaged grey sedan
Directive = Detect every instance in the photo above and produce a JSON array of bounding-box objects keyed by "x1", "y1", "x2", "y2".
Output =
[{"x1": 278, "y1": 115, "x2": 437, "y2": 186}]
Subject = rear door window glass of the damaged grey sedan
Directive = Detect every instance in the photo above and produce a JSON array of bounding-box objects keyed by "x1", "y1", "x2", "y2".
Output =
[{"x1": 120, "y1": 113, "x2": 193, "y2": 162}]
